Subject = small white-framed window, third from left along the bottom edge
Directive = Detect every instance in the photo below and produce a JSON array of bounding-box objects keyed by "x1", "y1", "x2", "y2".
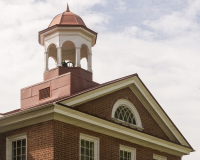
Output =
[{"x1": 120, "y1": 145, "x2": 136, "y2": 160}]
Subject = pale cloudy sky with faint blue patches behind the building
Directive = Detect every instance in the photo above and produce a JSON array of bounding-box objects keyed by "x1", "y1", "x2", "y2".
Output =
[{"x1": 0, "y1": 0, "x2": 200, "y2": 160}]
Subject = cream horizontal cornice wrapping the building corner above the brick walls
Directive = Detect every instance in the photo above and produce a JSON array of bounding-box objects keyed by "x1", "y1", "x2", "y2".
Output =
[{"x1": 0, "y1": 103, "x2": 192, "y2": 156}]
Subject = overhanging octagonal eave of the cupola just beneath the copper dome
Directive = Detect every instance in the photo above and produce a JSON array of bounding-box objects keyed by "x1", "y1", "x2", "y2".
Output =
[{"x1": 38, "y1": 24, "x2": 97, "y2": 47}]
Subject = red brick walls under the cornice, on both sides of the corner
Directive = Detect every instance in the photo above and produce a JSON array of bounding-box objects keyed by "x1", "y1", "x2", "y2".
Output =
[{"x1": 0, "y1": 120, "x2": 181, "y2": 160}]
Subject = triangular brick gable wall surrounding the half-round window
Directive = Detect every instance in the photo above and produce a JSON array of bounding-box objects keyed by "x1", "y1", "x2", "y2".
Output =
[{"x1": 75, "y1": 88, "x2": 170, "y2": 141}]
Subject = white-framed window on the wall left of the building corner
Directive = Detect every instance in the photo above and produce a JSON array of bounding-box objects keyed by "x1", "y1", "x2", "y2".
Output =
[{"x1": 6, "y1": 133, "x2": 27, "y2": 160}]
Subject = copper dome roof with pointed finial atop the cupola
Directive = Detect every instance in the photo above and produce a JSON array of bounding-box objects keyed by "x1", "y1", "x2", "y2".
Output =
[{"x1": 48, "y1": 5, "x2": 86, "y2": 28}]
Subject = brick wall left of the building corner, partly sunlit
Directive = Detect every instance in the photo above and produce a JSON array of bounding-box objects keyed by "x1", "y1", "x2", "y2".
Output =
[{"x1": 0, "y1": 121, "x2": 54, "y2": 160}]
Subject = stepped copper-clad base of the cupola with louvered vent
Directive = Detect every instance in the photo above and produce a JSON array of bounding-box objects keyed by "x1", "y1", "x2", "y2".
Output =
[{"x1": 21, "y1": 67, "x2": 99, "y2": 109}]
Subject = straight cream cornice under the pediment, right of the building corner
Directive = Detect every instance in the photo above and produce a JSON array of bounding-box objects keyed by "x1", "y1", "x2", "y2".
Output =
[{"x1": 54, "y1": 104, "x2": 191, "y2": 156}]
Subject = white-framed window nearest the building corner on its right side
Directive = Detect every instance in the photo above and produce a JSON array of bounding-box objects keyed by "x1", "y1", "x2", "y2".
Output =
[{"x1": 80, "y1": 133, "x2": 99, "y2": 160}]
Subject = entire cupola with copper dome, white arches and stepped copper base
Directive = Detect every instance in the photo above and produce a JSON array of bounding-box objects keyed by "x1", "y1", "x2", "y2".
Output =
[{"x1": 21, "y1": 5, "x2": 98, "y2": 109}]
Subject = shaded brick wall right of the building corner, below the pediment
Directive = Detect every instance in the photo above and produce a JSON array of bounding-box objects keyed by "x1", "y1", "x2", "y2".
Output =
[{"x1": 55, "y1": 121, "x2": 181, "y2": 160}]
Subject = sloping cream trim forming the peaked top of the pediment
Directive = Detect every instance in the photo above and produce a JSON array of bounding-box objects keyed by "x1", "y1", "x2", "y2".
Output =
[{"x1": 62, "y1": 76, "x2": 190, "y2": 147}]
